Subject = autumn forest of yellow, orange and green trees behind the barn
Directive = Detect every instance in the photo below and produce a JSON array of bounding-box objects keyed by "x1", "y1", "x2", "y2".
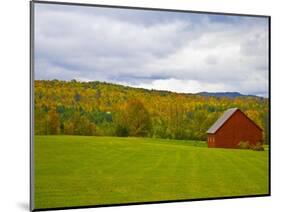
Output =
[{"x1": 35, "y1": 80, "x2": 268, "y2": 143}]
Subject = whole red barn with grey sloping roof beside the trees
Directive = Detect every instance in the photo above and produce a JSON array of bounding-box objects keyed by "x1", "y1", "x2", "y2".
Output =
[{"x1": 207, "y1": 108, "x2": 262, "y2": 148}]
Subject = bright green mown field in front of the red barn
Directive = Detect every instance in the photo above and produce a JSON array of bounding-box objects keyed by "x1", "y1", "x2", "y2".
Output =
[{"x1": 35, "y1": 136, "x2": 268, "y2": 208}]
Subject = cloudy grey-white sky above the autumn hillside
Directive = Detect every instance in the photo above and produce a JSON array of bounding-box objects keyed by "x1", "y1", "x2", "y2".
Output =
[{"x1": 35, "y1": 3, "x2": 268, "y2": 96}]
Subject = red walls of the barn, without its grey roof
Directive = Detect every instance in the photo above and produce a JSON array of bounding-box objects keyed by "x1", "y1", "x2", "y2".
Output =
[{"x1": 214, "y1": 110, "x2": 262, "y2": 148}]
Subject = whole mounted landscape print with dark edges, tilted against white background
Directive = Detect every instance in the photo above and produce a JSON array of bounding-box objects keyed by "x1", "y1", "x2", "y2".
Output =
[{"x1": 31, "y1": 1, "x2": 270, "y2": 210}]
